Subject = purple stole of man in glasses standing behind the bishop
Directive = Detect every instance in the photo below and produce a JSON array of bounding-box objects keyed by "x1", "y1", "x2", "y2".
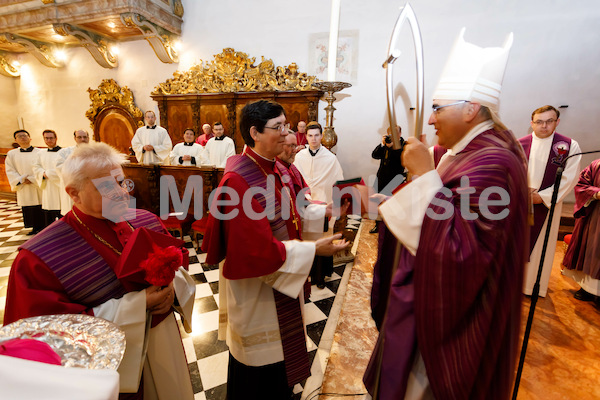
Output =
[{"x1": 519, "y1": 132, "x2": 571, "y2": 254}]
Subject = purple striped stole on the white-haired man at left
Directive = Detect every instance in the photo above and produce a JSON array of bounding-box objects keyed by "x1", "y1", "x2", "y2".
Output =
[{"x1": 19, "y1": 210, "x2": 162, "y2": 308}]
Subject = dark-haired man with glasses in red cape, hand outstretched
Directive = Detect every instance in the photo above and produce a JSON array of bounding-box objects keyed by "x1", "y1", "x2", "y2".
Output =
[{"x1": 202, "y1": 100, "x2": 348, "y2": 400}]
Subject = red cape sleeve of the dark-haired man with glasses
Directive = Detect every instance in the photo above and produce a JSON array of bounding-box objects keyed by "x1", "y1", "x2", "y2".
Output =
[{"x1": 202, "y1": 172, "x2": 286, "y2": 279}]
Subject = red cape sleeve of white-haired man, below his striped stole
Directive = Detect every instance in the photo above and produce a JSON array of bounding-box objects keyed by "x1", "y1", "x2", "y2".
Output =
[{"x1": 4, "y1": 249, "x2": 94, "y2": 325}]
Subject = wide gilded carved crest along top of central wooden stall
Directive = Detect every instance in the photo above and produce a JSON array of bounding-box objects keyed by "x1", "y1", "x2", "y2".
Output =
[{"x1": 152, "y1": 48, "x2": 317, "y2": 94}]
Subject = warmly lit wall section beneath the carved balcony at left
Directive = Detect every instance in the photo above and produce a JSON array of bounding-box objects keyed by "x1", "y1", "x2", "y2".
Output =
[{"x1": 5, "y1": 41, "x2": 176, "y2": 146}]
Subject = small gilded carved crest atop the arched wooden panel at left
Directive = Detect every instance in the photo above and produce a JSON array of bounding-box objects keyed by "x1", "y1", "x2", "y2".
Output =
[{"x1": 85, "y1": 79, "x2": 143, "y2": 127}]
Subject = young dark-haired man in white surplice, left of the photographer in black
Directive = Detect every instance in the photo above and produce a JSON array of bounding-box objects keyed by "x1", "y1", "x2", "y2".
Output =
[{"x1": 294, "y1": 121, "x2": 344, "y2": 204}]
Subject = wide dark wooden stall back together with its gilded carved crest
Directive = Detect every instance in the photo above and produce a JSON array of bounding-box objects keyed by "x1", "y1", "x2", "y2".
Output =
[{"x1": 152, "y1": 48, "x2": 323, "y2": 153}]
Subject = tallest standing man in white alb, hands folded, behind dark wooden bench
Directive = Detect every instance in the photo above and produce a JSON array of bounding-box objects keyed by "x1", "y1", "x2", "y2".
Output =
[{"x1": 131, "y1": 110, "x2": 173, "y2": 164}]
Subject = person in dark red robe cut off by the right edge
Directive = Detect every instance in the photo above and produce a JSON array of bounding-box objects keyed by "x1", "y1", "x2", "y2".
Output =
[{"x1": 563, "y1": 160, "x2": 600, "y2": 307}]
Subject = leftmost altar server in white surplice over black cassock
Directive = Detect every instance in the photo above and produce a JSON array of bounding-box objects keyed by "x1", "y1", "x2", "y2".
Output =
[{"x1": 4, "y1": 129, "x2": 44, "y2": 235}]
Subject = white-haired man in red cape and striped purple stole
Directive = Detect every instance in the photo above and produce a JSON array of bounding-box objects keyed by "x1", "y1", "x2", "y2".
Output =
[{"x1": 4, "y1": 142, "x2": 195, "y2": 400}]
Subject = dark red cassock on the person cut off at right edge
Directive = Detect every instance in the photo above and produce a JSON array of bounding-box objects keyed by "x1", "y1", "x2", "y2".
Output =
[{"x1": 563, "y1": 160, "x2": 600, "y2": 279}]
